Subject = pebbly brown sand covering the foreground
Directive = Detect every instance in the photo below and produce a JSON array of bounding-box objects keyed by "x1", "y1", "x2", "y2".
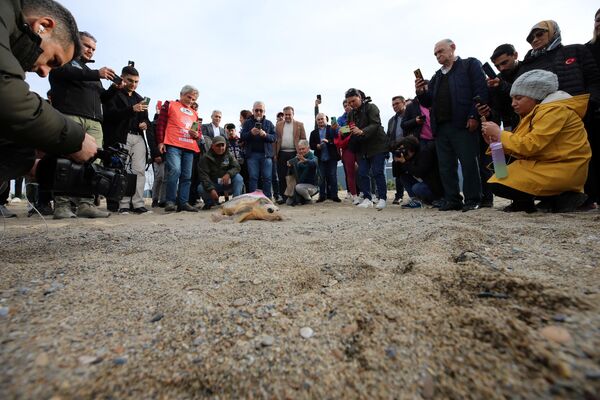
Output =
[{"x1": 0, "y1": 195, "x2": 600, "y2": 400}]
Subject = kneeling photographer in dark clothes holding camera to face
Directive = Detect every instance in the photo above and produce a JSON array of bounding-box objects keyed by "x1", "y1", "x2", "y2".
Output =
[{"x1": 393, "y1": 136, "x2": 443, "y2": 208}]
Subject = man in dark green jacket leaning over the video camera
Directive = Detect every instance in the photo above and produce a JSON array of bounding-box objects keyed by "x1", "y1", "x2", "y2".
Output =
[{"x1": 0, "y1": 0, "x2": 97, "y2": 181}]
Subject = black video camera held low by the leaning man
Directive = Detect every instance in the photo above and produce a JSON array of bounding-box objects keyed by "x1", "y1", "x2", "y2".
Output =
[{"x1": 36, "y1": 143, "x2": 137, "y2": 200}]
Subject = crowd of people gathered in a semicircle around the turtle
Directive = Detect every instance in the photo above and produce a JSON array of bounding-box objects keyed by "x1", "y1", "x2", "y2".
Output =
[{"x1": 0, "y1": 0, "x2": 600, "y2": 219}]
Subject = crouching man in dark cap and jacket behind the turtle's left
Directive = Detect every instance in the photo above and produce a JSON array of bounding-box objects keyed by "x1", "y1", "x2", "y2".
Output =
[{"x1": 198, "y1": 136, "x2": 244, "y2": 210}]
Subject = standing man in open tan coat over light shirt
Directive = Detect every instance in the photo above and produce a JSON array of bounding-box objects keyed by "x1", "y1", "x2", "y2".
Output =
[{"x1": 273, "y1": 106, "x2": 306, "y2": 204}]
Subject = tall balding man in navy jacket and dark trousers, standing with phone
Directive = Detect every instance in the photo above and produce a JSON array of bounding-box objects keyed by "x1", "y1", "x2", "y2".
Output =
[{"x1": 415, "y1": 39, "x2": 488, "y2": 211}]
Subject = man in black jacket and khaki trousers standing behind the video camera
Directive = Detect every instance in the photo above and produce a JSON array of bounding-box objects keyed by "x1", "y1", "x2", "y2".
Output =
[{"x1": 49, "y1": 32, "x2": 116, "y2": 219}]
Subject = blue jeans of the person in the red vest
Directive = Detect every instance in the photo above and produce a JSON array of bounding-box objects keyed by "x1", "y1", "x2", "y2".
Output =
[{"x1": 166, "y1": 145, "x2": 194, "y2": 205}]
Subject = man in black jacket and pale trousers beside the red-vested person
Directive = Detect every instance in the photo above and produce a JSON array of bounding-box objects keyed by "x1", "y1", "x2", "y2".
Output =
[{"x1": 102, "y1": 65, "x2": 150, "y2": 214}]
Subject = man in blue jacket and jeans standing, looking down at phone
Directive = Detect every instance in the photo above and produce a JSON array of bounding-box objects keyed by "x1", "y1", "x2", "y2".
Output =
[{"x1": 240, "y1": 101, "x2": 277, "y2": 198}]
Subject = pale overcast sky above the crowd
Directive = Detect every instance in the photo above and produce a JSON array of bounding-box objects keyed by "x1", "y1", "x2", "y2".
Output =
[{"x1": 27, "y1": 0, "x2": 600, "y2": 127}]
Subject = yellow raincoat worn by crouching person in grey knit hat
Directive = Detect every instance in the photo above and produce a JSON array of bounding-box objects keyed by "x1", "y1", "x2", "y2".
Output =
[{"x1": 488, "y1": 91, "x2": 592, "y2": 196}]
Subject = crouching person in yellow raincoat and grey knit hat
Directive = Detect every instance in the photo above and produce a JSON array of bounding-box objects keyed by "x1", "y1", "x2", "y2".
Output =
[{"x1": 482, "y1": 69, "x2": 592, "y2": 212}]
